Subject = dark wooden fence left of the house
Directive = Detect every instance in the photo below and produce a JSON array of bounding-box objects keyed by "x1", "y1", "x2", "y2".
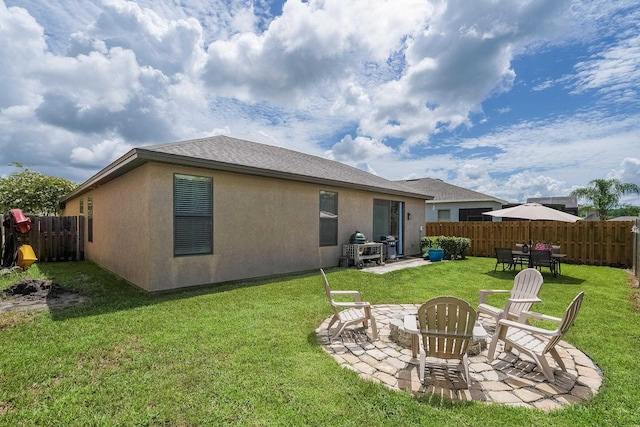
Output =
[{"x1": 2, "y1": 215, "x2": 84, "y2": 262}]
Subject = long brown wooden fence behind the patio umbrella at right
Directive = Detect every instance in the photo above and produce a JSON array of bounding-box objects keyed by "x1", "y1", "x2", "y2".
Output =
[{"x1": 425, "y1": 221, "x2": 634, "y2": 268}]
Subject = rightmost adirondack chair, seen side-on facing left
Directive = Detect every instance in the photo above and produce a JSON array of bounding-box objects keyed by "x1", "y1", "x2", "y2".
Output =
[{"x1": 487, "y1": 292, "x2": 584, "y2": 382}]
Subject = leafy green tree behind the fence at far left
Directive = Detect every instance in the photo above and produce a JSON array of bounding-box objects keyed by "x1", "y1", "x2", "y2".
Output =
[{"x1": 0, "y1": 162, "x2": 78, "y2": 215}]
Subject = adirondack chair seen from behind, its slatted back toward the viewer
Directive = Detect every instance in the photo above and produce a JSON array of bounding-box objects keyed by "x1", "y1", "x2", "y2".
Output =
[{"x1": 418, "y1": 296, "x2": 476, "y2": 388}]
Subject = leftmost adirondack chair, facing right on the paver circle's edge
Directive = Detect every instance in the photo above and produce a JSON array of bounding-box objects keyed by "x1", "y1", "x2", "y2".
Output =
[{"x1": 320, "y1": 269, "x2": 378, "y2": 340}]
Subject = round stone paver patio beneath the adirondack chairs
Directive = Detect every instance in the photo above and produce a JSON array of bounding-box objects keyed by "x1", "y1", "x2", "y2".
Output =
[{"x1": 316, "y1": 304, "x2": 602, "y2": 411}]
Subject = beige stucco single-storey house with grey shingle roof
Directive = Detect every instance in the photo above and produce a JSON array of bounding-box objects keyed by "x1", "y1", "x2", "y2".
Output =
[{"x1": 62, "y1": 136, "x2": 429, "y2": 292}]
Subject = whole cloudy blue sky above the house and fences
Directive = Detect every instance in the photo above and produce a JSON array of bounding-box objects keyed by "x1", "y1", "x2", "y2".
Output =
[{"x1": 0, "y1": 0, "x2": 640, "y2": 204}]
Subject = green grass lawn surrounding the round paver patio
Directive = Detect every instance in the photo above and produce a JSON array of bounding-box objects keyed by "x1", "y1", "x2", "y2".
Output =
[{"x1": 0, "y1": 258, "x2": 640, "y2": 427}]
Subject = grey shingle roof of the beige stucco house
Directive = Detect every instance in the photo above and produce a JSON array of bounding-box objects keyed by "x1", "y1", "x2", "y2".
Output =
[{"x1": 62, "y1": 135, "x2": 427, "y2": 203}]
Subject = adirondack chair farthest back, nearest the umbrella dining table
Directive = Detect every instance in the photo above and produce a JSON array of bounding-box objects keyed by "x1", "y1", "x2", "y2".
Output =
[{"x1": 477, "y1": 268, "x2": 544, "y2": 322}]
